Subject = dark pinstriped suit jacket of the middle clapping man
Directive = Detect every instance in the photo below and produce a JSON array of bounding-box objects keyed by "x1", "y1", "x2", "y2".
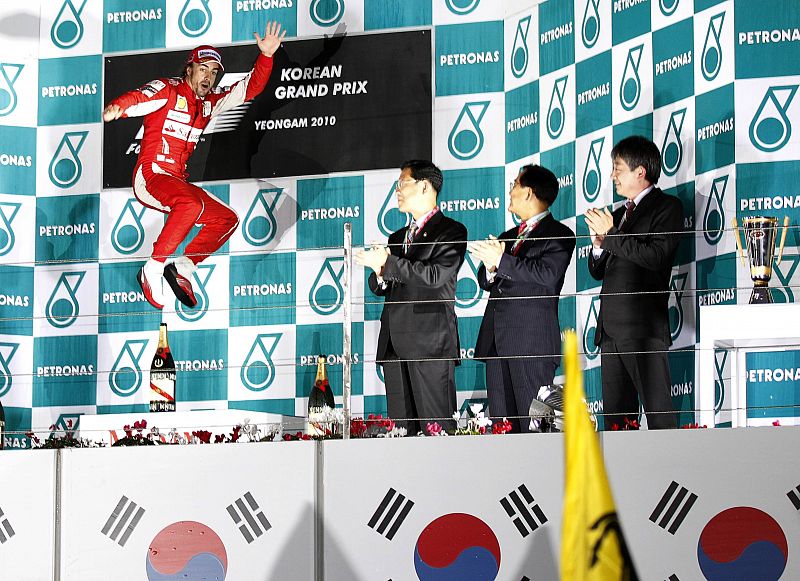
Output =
[{"x1": 475, "y1": 214, "x2": 575, "y2": 362}]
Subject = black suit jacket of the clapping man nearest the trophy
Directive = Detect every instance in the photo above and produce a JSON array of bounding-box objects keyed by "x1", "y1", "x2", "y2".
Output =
[{"x1": 589, "y1": 188, "x2": 683, "y2": 345}]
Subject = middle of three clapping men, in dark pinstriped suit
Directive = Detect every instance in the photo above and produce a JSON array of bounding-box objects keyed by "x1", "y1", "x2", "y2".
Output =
[{"x1": 470, "y1": 165, "x2": 575, "y2": 432}]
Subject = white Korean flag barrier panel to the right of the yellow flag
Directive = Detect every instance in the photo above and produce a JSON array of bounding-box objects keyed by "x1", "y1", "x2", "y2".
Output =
[{"x1": 603, "y1": 427, "x2": 800, "y2": 580}]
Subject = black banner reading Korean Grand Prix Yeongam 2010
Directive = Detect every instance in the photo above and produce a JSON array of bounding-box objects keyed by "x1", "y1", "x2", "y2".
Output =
[{"x1": 103, "y1": 30, "x2": 432, "y2": 188}]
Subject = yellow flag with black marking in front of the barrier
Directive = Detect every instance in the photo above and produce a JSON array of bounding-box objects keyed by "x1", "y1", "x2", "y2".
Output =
[{"x1": 561, "y1": 331, "x2": 637, "y2": 581}]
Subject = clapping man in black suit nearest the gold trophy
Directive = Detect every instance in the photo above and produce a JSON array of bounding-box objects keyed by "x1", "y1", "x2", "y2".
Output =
[{"x1": 584, "y1": 136, "x2": 683, "y2": 430}]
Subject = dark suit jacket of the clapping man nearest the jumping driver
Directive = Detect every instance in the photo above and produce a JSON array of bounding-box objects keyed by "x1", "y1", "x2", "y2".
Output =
[{"x1": 368, "y1": 211, "x2": 467, "y2": 360}]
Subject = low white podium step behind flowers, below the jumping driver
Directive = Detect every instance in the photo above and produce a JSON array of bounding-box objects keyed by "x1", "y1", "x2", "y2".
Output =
[{"x1": 79, "y1": 409, "x2": 306, "y2": 446}]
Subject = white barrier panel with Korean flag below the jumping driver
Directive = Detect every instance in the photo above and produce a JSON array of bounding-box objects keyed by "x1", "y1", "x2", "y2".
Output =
[{"x1": 61, "y1": 442, "x2": 315, "y2": 581}]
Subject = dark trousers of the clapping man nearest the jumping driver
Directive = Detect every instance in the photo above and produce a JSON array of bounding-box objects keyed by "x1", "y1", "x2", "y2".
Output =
[{"x1": 383, "y1": 345, "x2": 457, "y2": 436}]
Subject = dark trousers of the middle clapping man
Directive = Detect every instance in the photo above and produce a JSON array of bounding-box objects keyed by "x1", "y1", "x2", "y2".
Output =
[{"x1": 486, "y1": 346, "x2": 558, "y2": 434}]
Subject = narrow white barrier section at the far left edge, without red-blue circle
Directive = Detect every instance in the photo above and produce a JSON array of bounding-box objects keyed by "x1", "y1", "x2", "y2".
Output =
[{"x1": 0, "y1": 450, "x2": 55, "y2": 581}]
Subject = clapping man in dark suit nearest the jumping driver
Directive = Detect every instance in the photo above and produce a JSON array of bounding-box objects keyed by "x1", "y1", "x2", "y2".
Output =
[{"x1": 355, "y1": 160, "x2": 467, "y2": 435}]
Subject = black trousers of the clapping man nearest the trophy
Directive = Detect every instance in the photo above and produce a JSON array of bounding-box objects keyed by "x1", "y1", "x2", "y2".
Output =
[{"x1": 600, "y1": 336, "x2": 678, "y2": 430}]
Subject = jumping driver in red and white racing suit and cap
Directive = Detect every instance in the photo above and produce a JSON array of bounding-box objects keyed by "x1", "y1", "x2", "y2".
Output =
[{"x1": 103, "y1": 22, "x2": 286, "y2": 309}]
